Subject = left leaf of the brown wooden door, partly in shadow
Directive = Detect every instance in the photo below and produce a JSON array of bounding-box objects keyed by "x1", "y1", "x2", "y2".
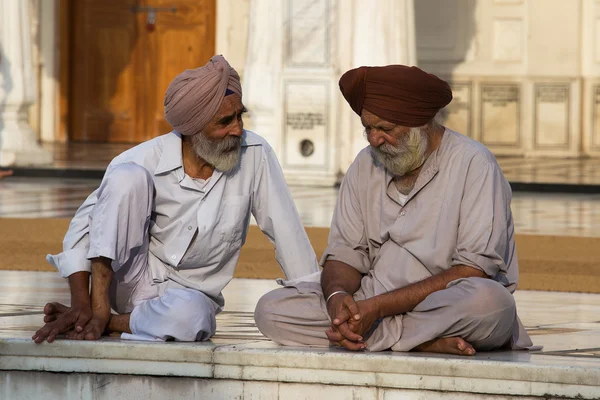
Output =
[{"x1": 71, "y1": 0, "x2": 138, "y2": 142}]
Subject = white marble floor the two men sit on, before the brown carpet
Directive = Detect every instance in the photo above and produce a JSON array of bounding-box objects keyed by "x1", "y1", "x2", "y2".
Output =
[{"x1": 0, "y1": 271, "x2": 600, "y2": 356}]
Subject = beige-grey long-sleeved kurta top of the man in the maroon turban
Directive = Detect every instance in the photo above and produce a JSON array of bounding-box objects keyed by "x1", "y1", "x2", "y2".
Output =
[{"x1": 321, "y1": 129, "x2": 519, "y2": 295}]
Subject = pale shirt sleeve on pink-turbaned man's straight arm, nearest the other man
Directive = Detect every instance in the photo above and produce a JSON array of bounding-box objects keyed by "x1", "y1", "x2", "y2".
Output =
[{"x1": 252, "y1": 144, "x2": 319, "y2": 280}]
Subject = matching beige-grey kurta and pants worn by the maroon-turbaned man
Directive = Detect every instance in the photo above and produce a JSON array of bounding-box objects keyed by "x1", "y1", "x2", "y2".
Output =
[{"x1": 255, "y1": 129, "x2": 531, "y2": 351}]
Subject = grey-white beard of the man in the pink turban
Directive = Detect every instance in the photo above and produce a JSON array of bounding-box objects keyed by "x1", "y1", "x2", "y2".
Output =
[{"x1": 191, "y1": 132, "x2": 242, "y2": 172}]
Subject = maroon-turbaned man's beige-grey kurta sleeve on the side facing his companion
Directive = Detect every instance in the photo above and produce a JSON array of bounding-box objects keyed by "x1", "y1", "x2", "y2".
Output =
[{"x1": 321, "y1": 158, "x2": 371, "y2": 274}]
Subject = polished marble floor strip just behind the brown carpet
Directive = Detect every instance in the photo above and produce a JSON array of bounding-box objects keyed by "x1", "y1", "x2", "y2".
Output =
[{"x1": 0, "y1": 177, "x2": 600, "y2": 237}]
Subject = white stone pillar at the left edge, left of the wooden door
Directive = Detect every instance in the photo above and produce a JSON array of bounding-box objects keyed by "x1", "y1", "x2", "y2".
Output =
[{"x1": 0, "y1": 0, "x2": 52, "y2": 166}]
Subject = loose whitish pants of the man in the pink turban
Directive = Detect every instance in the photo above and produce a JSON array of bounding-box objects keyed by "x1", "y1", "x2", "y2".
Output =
[{"x1": 87, "y1": 163, "x2": 216, "y2": 341}]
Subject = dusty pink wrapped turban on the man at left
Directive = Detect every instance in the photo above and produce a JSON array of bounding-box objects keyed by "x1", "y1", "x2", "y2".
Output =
[{"x1": 165, "y1": 55, "x2": 242, "y2": 135}]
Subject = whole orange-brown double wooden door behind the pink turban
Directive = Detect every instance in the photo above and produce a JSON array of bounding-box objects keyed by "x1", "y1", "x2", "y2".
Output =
[{"x1": 69, "y1": 0, "x2": 216, "y2": 143}]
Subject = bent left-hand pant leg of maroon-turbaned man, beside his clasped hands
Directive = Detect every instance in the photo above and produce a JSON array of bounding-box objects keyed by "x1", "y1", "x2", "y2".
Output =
[{"x1": 254, "y1": 282, "x2": 331, "y2": 347}]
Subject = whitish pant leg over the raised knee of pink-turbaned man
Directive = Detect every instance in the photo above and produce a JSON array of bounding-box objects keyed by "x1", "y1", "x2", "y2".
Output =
[{"x1": 87, "y1": 163, "x2": 158, "y2": 314}]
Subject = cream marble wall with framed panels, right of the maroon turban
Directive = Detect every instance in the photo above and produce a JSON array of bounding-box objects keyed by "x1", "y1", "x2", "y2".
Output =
[{"x1": 415, "y1": 0, "x2": 584, "y2": 157}]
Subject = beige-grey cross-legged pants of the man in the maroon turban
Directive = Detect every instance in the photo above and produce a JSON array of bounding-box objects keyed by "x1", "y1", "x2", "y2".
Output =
[{"x1": 255, "y1": 278, "x2": 532, "y2": 351}]
